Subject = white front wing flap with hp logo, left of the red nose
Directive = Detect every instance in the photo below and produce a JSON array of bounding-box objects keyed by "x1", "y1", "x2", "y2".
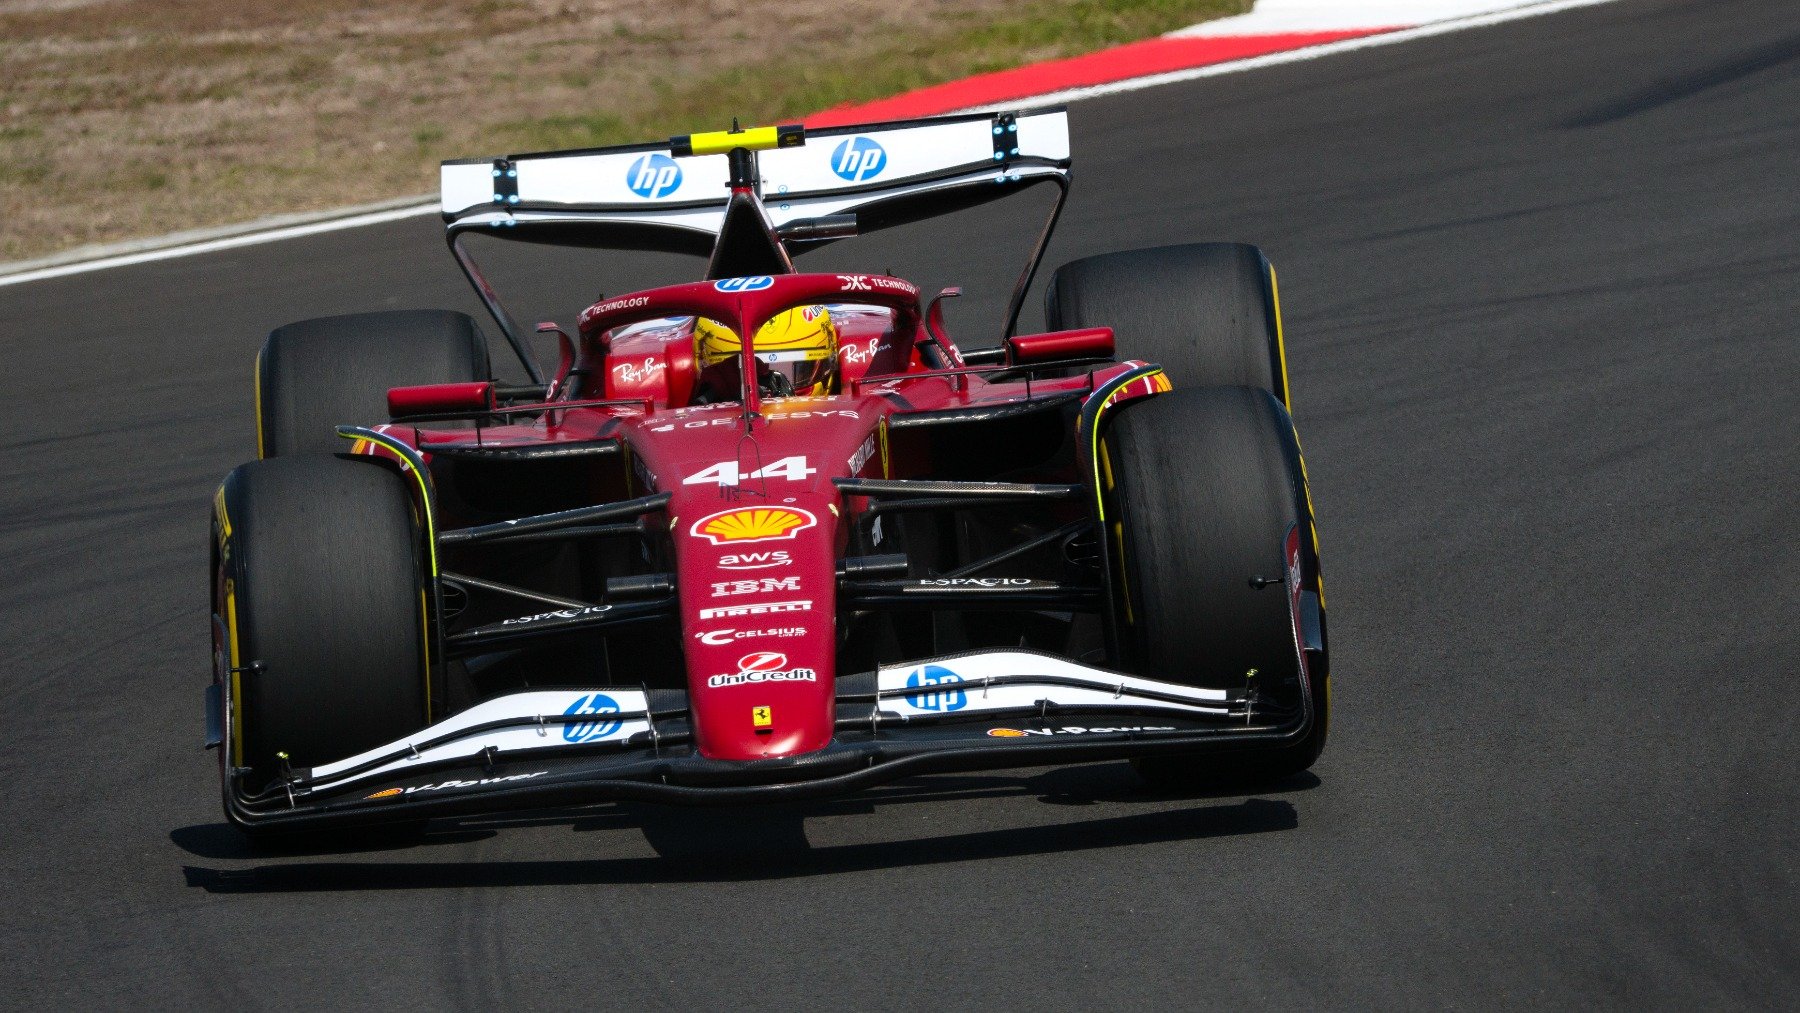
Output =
[{"x1": 310, "y1": 689, "x2": 650, "y2": 790}]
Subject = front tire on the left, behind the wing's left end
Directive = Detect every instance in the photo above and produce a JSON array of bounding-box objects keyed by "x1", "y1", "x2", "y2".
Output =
[{"x1": 214, "y1": 455, "x2": 428, "y2": 792}]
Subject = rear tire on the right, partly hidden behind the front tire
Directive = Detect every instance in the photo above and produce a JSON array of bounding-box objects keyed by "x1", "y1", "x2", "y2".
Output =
[{"x1": 1044, "y1": 243, "x2": 1287, "y2": 405}]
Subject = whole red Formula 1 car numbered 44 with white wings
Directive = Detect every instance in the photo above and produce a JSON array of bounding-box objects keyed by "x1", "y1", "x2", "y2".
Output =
[{"x1": 207, "y1": 108, "x2": 1327, "y2": 833}]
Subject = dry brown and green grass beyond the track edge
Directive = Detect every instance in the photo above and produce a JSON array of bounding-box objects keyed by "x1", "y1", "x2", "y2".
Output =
[{"x1": 0, "y1": 0, "x2": 1249, "y2": 261}]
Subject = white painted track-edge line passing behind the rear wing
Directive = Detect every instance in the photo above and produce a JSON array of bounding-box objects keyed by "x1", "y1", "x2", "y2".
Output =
[{"x1": 0, "y1": 0, "x2": 1615, "y2": 288}]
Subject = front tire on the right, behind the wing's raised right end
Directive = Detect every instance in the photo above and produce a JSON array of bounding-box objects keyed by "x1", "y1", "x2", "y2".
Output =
[{"x1": 1103, "y1": 387, "x2": 1328, "y2": 790}]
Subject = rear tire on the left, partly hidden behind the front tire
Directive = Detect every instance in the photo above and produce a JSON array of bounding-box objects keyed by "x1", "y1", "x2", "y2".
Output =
[{"x1": 256, "y1": 309, "x2": 491, "y2": 457}]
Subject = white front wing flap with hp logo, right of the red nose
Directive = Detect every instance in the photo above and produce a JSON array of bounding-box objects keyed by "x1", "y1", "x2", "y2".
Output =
[{"x1": 877, "y1": 651, "x2": 1231, "y2": 722}]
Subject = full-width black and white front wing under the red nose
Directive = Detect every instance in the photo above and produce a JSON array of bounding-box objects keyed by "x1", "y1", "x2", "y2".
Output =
[{"x1": 214, "y1": 650, "x2": 1318, "y2": 831}]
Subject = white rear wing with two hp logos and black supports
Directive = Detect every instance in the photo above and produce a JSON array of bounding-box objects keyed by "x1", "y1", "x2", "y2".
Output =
[{"x1": 441, "y1": 106, "x2": 1069, "y2": 381}]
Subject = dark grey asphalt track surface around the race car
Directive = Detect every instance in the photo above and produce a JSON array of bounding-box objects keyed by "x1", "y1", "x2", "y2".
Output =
[{"x1": 0, "y1": 0, "x2": 1800, "y2": 1009}]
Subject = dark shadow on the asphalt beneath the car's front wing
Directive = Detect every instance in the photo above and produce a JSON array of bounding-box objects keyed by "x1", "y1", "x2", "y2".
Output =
[{"x1": 169, "y1": 765, "x2": 1319, "y2": 892}]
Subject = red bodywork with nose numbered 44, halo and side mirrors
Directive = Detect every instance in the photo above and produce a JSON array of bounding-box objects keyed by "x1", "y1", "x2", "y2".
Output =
[{"x1": 358, "y1": 273, "x2": 1166, "y2": 761}]
